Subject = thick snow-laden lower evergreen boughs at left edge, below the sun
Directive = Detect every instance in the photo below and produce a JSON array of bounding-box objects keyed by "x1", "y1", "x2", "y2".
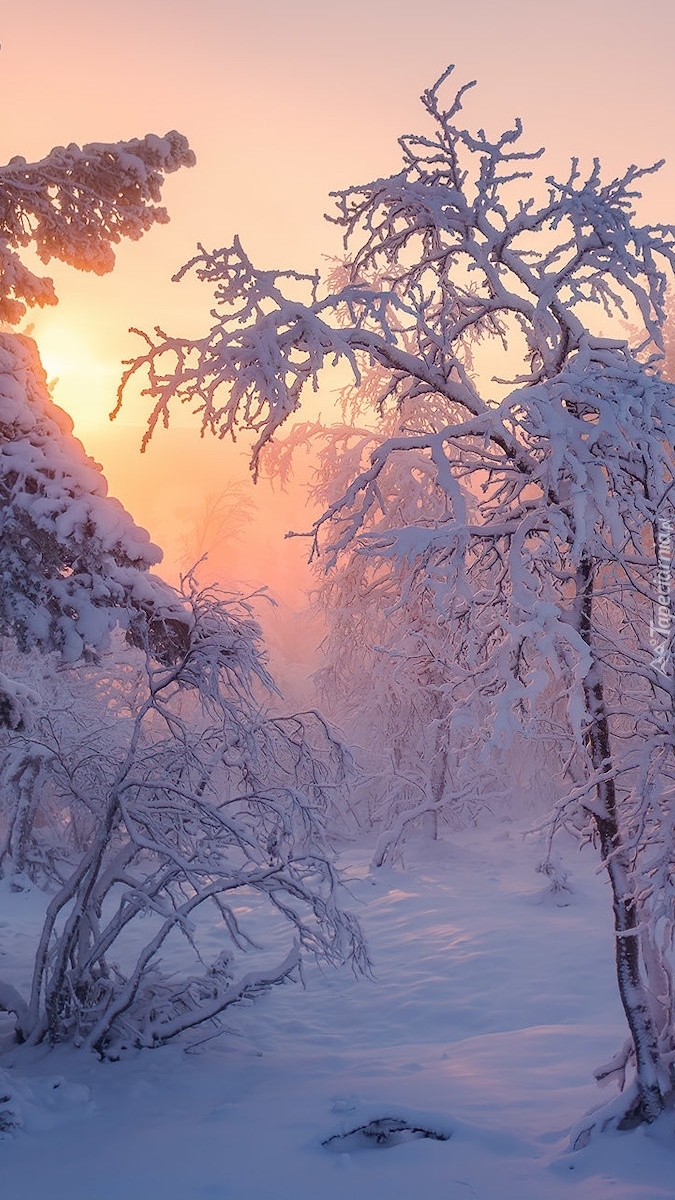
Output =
[{"x1": 0, "y1": 334, "x2": 186, "y2": 662}]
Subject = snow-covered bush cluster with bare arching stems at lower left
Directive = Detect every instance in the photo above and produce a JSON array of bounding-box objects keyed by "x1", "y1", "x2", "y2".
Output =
[{"x1": 0, "y1": 583, "x2": 365, "y2": 1056}]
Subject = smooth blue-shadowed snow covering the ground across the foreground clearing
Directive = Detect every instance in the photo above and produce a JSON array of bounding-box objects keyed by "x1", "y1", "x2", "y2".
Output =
[{"x1": 0, "y1": 826, "x2": 675, "y2": 1200}]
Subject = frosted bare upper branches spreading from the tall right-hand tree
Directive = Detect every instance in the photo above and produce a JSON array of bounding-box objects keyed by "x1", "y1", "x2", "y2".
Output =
[{"x1": 118, "y1": 71, "x2": 675, "y2": 489}]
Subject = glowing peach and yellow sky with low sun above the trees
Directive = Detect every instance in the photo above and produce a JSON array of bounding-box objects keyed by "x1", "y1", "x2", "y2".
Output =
[{"x1": 0, "y1": 0, "x2": 675, "y2": 614}]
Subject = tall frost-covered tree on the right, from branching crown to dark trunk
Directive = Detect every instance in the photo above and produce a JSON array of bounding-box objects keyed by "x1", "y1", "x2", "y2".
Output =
[{"x1": 119, "y1": 74, "x2": 675, "y2": 1124}]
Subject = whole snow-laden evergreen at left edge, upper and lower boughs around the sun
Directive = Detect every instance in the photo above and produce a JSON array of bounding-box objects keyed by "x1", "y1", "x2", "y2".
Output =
[{"x1": 0, "y1": 132, "x2": 195, "y2": 696}]
